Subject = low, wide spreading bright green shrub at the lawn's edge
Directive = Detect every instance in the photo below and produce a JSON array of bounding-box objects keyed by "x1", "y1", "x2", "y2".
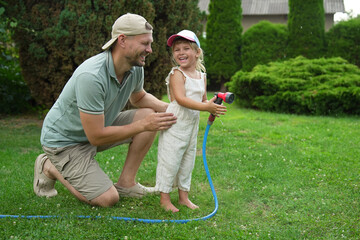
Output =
[{"x1": 228, "y1": 56, "x2": 360, "y2": 115}]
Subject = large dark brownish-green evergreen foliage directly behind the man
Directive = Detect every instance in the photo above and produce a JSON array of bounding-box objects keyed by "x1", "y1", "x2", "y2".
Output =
[{"x1": 7, "y1": 0, "x2": 201, "y2": 107}]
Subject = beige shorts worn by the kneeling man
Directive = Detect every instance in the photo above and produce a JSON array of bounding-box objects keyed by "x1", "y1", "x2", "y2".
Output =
[{"x1": 43, "y1": 110, "x2": 136, "y2": 201}]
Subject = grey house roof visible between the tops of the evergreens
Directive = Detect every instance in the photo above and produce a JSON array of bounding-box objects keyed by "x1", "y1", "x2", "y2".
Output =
[{"x1": 198, "y1": 0, "x2": 345, "y2": 15}]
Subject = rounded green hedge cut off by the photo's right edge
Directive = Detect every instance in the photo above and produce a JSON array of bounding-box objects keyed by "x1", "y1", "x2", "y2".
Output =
[{"x1": 326, "y1": 16, "x2": 360, "y2": 67}]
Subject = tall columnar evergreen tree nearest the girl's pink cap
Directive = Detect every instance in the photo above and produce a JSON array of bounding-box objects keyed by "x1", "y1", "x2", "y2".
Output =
[{"x1": 205, "y1": 0, "x2": 242, "y2": 91}]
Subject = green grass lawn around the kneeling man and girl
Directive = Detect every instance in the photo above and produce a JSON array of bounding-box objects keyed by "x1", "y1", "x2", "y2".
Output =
[{"x1": 0, "y1": 104, "x2": 360, "y2": 239}]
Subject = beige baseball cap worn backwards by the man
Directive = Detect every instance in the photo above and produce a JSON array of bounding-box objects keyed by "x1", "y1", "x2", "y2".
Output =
[{"x1": 102, "y1": 13, "x2": 153, "y2": 50}]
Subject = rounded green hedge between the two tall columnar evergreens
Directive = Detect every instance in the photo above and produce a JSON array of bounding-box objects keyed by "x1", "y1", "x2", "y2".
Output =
[{"x1": 241, "y1": 21, "x2": 288, "y2": 71}]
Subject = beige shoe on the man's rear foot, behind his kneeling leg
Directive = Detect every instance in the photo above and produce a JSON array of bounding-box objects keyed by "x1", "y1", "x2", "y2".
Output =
[{"x1": 34, "y1": 154, "x2": 57, "y2": 197}]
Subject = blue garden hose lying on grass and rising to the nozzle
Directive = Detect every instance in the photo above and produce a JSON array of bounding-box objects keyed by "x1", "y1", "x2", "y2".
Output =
[{"x1": 0, "y1": 122, "x2": 219, "y2": 223}]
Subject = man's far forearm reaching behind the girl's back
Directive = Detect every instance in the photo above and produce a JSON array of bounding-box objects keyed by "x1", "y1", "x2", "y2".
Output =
[{"x1": 130, "y1": 90, "x2": 169, "y2": 112}]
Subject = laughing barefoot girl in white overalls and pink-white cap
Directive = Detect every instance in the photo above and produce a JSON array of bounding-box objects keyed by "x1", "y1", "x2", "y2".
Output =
[{"x1": 155, "y1": 30, "x2": 226, "y2": 212}]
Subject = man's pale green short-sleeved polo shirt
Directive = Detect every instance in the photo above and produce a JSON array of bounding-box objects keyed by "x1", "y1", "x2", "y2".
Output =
[{"x1": 41, "y1": 51, "x2": 144, "y2": 147}]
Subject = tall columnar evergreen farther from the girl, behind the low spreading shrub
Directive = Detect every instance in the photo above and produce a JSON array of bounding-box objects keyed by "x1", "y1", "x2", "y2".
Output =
[{"x1": 287, "y1": 0, "x2": 325, "y2": 58}]
